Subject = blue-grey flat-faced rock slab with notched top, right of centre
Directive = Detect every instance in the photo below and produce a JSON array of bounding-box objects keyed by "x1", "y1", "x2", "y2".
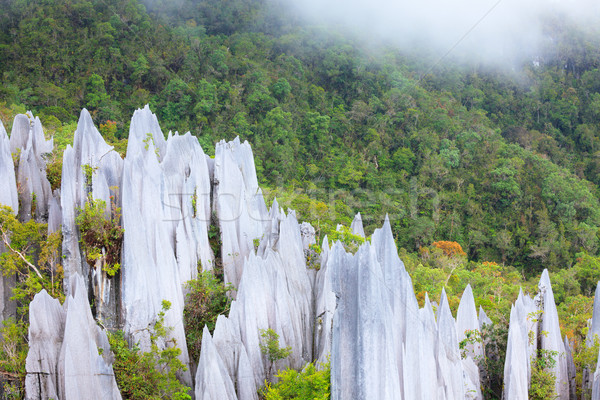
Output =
[{"x1": 328, "y1": 241, "x2": 402, "y2": 400}]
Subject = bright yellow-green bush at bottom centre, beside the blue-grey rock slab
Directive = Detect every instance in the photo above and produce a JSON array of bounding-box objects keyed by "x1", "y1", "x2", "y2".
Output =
[{"x1": 259, "y1": 362, "x2": 331, "y2": 400}]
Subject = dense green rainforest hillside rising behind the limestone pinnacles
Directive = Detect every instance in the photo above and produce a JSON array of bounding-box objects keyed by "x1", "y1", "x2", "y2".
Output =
[{"x1": 0, "y1": 0, "x2": 600, "y2": 396}]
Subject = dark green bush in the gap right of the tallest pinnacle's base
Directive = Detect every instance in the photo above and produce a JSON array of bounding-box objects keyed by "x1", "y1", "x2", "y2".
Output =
[{"x1": 183, "y1": 271, "x2": 231, "y2": 361}]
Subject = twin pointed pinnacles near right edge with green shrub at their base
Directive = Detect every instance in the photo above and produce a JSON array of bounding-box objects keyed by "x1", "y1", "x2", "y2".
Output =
[{"x1": 504, "y1": 270, "x2": 570, "y2": 400}]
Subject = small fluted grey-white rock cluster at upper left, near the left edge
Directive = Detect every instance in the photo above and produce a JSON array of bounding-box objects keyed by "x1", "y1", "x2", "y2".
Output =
[{"x1": 10, "y1": 112, "x2": 53, "y2": 221}]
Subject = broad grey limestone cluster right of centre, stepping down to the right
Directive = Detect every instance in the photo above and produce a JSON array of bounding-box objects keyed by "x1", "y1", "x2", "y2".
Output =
[{"x1": 324, "y1": 218, "x2": 481, "y2": 399}]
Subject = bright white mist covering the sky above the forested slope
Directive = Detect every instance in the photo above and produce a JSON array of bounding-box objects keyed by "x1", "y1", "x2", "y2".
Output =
[{"x1": 284, "y1": 0, "x2": 600, "y2": 63}]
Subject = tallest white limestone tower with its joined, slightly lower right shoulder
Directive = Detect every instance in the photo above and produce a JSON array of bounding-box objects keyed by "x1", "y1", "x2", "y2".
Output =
[{"x1": 122, "y1": 107, "x2": 213, "y2": 385}]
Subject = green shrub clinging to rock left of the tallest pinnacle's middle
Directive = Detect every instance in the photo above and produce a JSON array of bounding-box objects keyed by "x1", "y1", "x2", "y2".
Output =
[{"x1": 75, "y1": 196, "x2": 124, "y2": 277}]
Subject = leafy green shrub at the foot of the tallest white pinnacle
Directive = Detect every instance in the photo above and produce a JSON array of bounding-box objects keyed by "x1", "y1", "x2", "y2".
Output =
[{"x1": 108, "y1": 301, "x2": 191, "y2": 400}]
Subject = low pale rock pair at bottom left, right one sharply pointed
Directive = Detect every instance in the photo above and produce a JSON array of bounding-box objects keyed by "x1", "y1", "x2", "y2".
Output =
[{"x1": 25, "y1": 276, "x2": 121, "y2": 400}]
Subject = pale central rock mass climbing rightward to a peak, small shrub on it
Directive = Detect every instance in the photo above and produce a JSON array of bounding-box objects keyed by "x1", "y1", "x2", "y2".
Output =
[{"x1": 196, "y1": 202, "x2": 313, "y2": 400}]
